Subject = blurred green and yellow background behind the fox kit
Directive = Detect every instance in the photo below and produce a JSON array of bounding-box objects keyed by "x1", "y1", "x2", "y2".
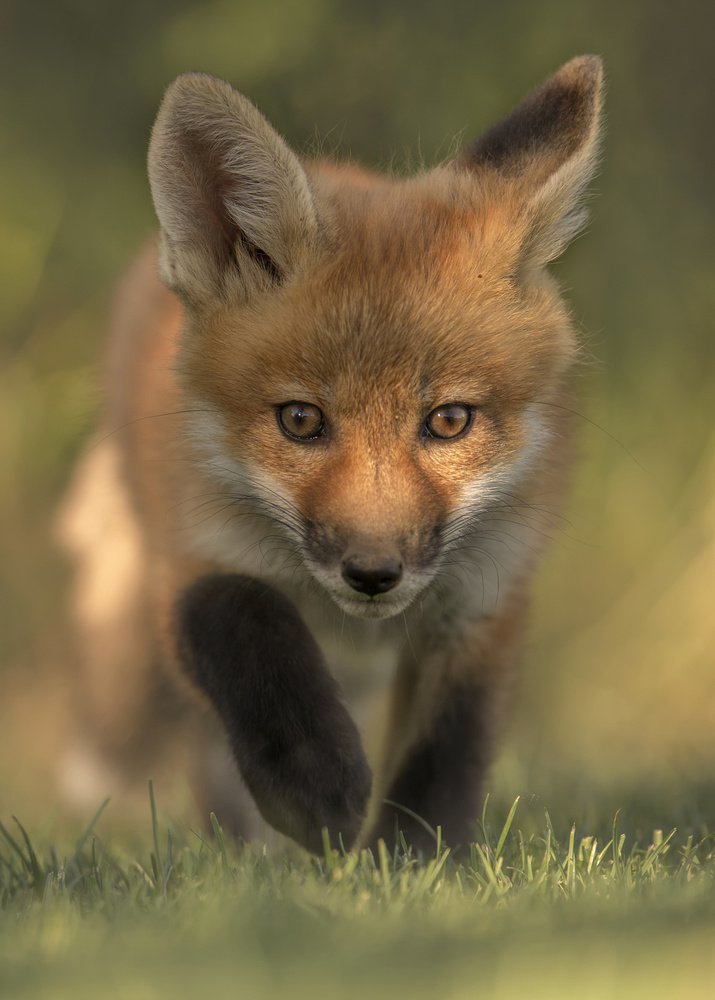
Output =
[{"x1": 0, "y1": 0, "x2": 715, "y2": 828}]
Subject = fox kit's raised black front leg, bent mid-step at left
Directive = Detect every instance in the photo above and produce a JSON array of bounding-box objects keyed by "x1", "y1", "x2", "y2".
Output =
[{"x1": 176, "y1": 574, "x2": 372, "y2": 852}]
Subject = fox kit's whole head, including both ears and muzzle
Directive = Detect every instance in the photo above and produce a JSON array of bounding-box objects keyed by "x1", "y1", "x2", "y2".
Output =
[{"x1": 149, "y1": 56, "x2": 601, "y2": 617}]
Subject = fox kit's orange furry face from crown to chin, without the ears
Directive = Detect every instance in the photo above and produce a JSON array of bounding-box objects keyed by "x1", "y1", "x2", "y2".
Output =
[{"x1": 148, "y1": 86, "x2": 592, "y2": 617}]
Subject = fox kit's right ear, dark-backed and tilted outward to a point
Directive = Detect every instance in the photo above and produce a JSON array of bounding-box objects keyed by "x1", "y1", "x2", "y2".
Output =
[{"x1": 455, "y1": 56, "x2": 603, "y2": 265}]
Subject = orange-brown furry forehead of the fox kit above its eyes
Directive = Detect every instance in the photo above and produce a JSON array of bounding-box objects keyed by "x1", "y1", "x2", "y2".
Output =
[{"x1": 186, "y1": 175, "x2": 573, "y2": 418}]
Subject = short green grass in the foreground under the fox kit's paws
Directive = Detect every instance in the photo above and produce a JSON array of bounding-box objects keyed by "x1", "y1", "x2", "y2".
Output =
[{"x1": 0, "y1": 790, "x2": 715, "y2": 1000}]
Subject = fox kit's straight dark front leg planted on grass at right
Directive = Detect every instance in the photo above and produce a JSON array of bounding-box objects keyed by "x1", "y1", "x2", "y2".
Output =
[{"x1": 369, "y1": 598, "x2": 524, "y2": 851}]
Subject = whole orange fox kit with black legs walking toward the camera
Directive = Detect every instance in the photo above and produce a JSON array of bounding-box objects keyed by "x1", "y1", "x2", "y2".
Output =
[{"x1": 58, "y1": 56, "x2": 601, "y2": 851}]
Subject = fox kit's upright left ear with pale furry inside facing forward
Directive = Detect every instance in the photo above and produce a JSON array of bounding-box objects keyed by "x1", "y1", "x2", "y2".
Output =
[{"x1": 149, "y1": 73, "x2": 317, "y2": 303}]
